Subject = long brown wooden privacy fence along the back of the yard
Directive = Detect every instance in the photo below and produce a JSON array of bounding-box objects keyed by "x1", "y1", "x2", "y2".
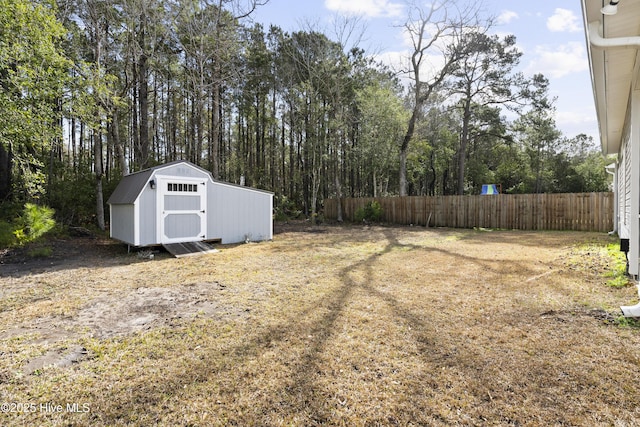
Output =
[{"x1": 324, "y1": 193, "x2": 614, "y2": 232}]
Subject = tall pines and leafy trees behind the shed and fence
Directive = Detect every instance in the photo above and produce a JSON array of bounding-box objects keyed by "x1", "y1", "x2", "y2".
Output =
[{"x1": 0, "y1": 0, "x2": 607, "y2": 228}]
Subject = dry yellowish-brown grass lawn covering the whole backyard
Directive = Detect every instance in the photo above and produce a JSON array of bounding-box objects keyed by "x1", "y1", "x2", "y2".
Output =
[{"x1": 0, "y1": 225, "x2": 640, "y2": 426}]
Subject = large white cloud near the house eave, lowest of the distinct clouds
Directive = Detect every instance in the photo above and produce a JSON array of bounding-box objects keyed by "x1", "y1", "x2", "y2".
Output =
[{"x1": 525, "y1": 42, "x2": 589, "y2": 78}]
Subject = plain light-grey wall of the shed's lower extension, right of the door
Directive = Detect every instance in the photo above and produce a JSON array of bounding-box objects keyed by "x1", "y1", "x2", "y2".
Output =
[{"x1": 208, "y1": 182, "x2": 273, "y2": 243}]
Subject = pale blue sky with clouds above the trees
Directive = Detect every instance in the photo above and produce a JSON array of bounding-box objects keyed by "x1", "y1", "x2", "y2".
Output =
[{"x1": 246, "y1": 0, "x2": 598, "y2": 141}]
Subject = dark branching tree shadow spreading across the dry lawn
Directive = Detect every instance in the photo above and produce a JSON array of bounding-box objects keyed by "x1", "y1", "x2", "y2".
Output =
[{"x1": 62, "y1": 226, "x2": 592, "y2": 425}]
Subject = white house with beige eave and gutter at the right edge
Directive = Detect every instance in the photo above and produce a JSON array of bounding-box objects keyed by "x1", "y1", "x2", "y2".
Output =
[{"x1": 581, "y1": 0, "x2": 640, "y2": 310}]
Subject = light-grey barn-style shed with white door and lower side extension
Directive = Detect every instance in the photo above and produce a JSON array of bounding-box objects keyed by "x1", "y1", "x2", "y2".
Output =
[{"x1": 107, "y1": 161, "x2": 273, "y2": 246}]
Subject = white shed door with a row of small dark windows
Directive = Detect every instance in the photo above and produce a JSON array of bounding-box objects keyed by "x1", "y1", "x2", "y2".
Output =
[{"x1": 157, "y1": 176, "x2": 207, "y2": 243}]
